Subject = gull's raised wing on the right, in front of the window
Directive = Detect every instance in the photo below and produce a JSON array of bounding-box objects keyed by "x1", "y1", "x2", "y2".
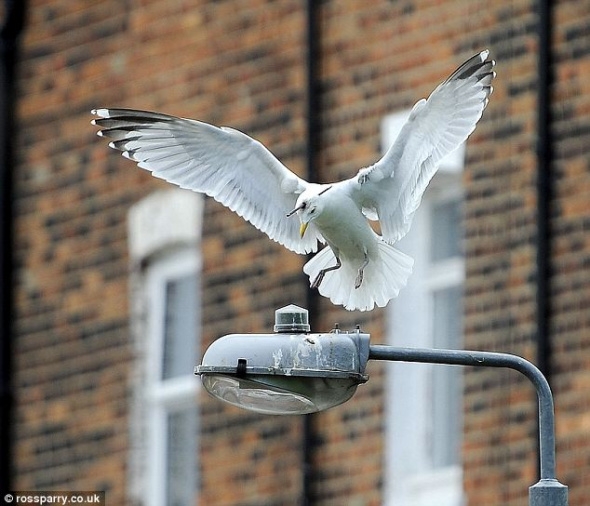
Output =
[{"x1": 349, "y1": 50, "x2": 495, "y2": 243}]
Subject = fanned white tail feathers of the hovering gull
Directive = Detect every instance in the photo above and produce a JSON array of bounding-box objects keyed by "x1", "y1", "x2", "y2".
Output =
[{"x1": 303, "y1": 241, "x2": 414, "y2": 311}]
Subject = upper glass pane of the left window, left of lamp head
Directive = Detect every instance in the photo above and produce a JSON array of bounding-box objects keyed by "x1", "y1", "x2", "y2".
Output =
[{"x1": 162, "y1": 274, "x2": 200, "y2": 379}]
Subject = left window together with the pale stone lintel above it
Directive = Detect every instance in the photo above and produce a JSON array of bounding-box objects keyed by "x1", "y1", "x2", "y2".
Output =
[{"x1": 129, "y1": 189, "x2": 202, "y2": 506}]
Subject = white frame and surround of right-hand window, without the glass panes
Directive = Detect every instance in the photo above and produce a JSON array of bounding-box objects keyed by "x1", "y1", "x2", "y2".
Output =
[{"x1": 382, "y1": 110, "x2": 465, "y2": 506}]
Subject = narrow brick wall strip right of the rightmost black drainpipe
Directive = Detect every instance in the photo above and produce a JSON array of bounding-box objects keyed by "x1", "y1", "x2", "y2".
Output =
[{"x1": 551, "y1": 2, "x2": 590, "y2": 504}]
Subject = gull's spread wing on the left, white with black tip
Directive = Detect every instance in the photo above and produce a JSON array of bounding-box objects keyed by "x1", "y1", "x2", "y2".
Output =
[{"x1": 92, "y1": 109, "x2": 319, "y2": 253}]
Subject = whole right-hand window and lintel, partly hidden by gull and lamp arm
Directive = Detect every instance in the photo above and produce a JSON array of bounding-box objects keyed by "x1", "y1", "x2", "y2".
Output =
[{"x1": 383, "y1": 111, "x2": 464, "y2": 506}]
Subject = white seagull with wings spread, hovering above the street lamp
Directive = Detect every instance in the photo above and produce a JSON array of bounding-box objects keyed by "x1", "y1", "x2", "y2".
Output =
[{"x1": 92, "y1": 50, "x2": 496, "y2": 311}]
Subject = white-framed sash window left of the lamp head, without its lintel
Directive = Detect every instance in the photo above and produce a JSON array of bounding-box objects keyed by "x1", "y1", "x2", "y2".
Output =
[{"x1": 146, "y1": 248, "x2": 200, "y2": 506}]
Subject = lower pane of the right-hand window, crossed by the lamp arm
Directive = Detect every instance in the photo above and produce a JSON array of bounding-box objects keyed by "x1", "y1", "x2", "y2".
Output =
[{"x1": 432, "y1": 286, "x2": 463, "y2": 468}]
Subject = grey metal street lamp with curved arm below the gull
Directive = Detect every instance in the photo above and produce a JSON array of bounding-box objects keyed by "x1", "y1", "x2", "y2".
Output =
[{"x1": 195, "y1": 305, "x2": 568, "y2": 506}]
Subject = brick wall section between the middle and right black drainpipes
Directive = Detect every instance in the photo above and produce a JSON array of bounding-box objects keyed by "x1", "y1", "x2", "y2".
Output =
[{"x1": 318, "y1": 1, "x2": 536, "y2": 505}]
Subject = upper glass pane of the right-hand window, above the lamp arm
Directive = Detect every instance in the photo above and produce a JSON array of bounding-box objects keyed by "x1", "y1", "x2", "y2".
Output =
[{"x1": 430, "y1": 199, "x2": 463, "y2": 262}]
